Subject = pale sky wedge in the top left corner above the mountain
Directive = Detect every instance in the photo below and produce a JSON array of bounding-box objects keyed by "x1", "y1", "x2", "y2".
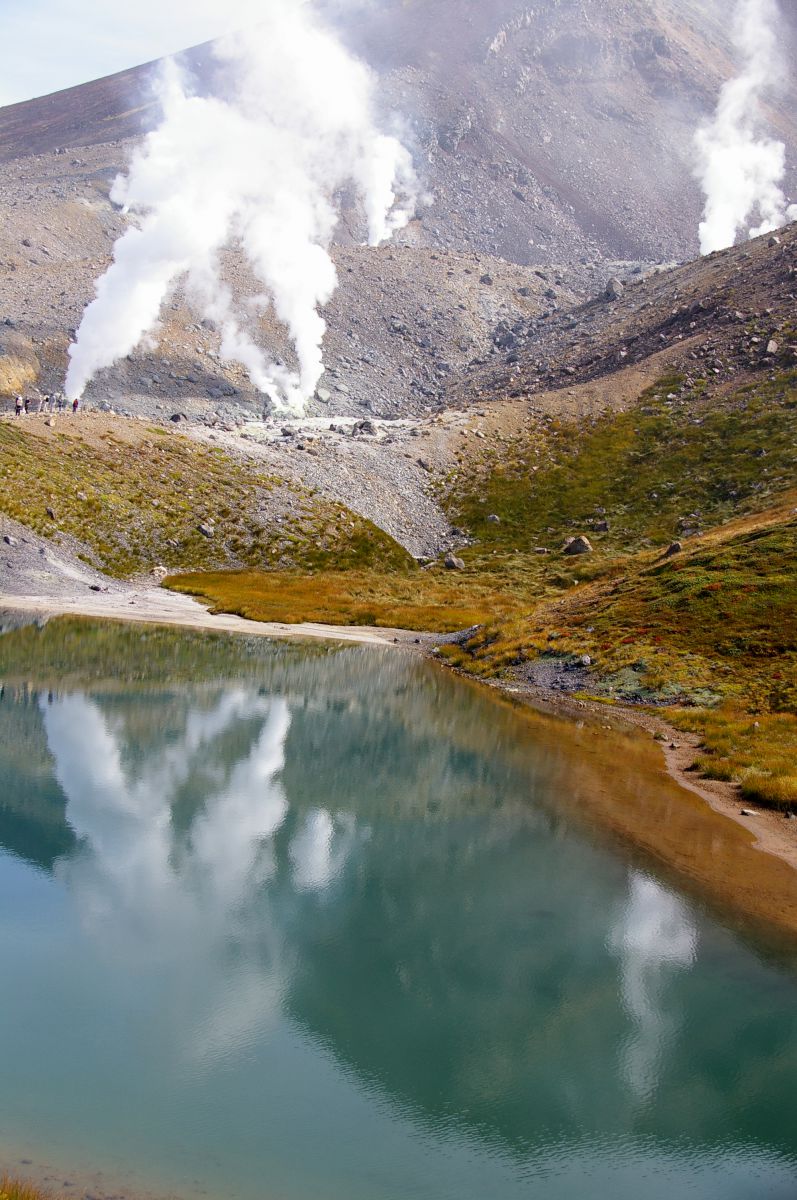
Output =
[{"x1": 0, "y1": 0, "x2": 268, "y2": 106}]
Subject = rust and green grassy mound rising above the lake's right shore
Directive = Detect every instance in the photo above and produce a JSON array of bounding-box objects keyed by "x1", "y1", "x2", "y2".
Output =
[{"x1": 445, "y1": 518, "x2": 797, "y2": 712}]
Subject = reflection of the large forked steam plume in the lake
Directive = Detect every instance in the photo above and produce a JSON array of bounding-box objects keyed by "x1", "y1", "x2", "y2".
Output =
[{"x1": 41, "y1": 690, "x2": 352, "y2": 1062}]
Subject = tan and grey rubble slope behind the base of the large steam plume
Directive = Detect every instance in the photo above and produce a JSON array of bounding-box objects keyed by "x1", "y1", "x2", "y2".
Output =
[{"x1": 0, "y1": 132, "x2": 583, "y2": 416}]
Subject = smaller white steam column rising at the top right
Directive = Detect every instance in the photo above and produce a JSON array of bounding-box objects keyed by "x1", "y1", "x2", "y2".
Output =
[{"x1": 695, "y1": 0, "x2": 797, "y2": 254}]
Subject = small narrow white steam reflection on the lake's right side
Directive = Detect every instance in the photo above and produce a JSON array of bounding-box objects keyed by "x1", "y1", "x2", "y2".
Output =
[{"x1": 611, "y1": 872, "x2": 697, "y2": 1099}]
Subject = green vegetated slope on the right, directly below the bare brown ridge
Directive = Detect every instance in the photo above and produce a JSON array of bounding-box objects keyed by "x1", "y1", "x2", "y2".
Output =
[{"x1": 448, "y1": 370, "x2": 797, "y2": 568}]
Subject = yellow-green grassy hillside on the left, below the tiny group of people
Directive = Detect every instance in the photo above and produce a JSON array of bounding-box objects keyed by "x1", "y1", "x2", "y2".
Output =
[{"x1": 0, "y1": 422, "x2": 413, "y2": 577}]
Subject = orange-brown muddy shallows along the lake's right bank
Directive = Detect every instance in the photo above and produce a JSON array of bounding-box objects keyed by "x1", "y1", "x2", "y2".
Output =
[{"x1": 463, "y1": 679, "x2": 797, "y2": 942}]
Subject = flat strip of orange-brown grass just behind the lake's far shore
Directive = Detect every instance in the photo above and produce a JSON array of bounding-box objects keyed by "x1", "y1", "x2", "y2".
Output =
[{"x1": 167, "y1": 570, "x2": 517, "y2": 634}]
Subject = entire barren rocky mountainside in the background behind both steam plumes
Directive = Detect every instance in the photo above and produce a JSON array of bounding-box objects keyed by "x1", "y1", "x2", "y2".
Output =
[{"x1": 0, "y1": 0, "x2": 797, "y2": 421}]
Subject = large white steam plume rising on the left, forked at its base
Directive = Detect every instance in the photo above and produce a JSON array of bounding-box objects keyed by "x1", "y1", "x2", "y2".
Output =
[{"x1": 66, "y1": 0, "x2": 417, "y2": 410}]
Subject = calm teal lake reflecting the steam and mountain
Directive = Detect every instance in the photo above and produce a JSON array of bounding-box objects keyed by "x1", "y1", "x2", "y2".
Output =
[{"x1": 0, "y1": 624, "x2": 797, "y2": 1200}]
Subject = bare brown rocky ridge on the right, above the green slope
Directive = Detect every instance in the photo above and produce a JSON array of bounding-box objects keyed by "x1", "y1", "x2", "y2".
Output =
[{"x1": 448, "y1": 213, "x2": 797, "y2": 403}]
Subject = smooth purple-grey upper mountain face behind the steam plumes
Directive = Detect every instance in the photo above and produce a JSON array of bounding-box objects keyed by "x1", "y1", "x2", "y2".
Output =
[{"x1": 0, "y1": 0, "x2": 797, "y2": 263}]
